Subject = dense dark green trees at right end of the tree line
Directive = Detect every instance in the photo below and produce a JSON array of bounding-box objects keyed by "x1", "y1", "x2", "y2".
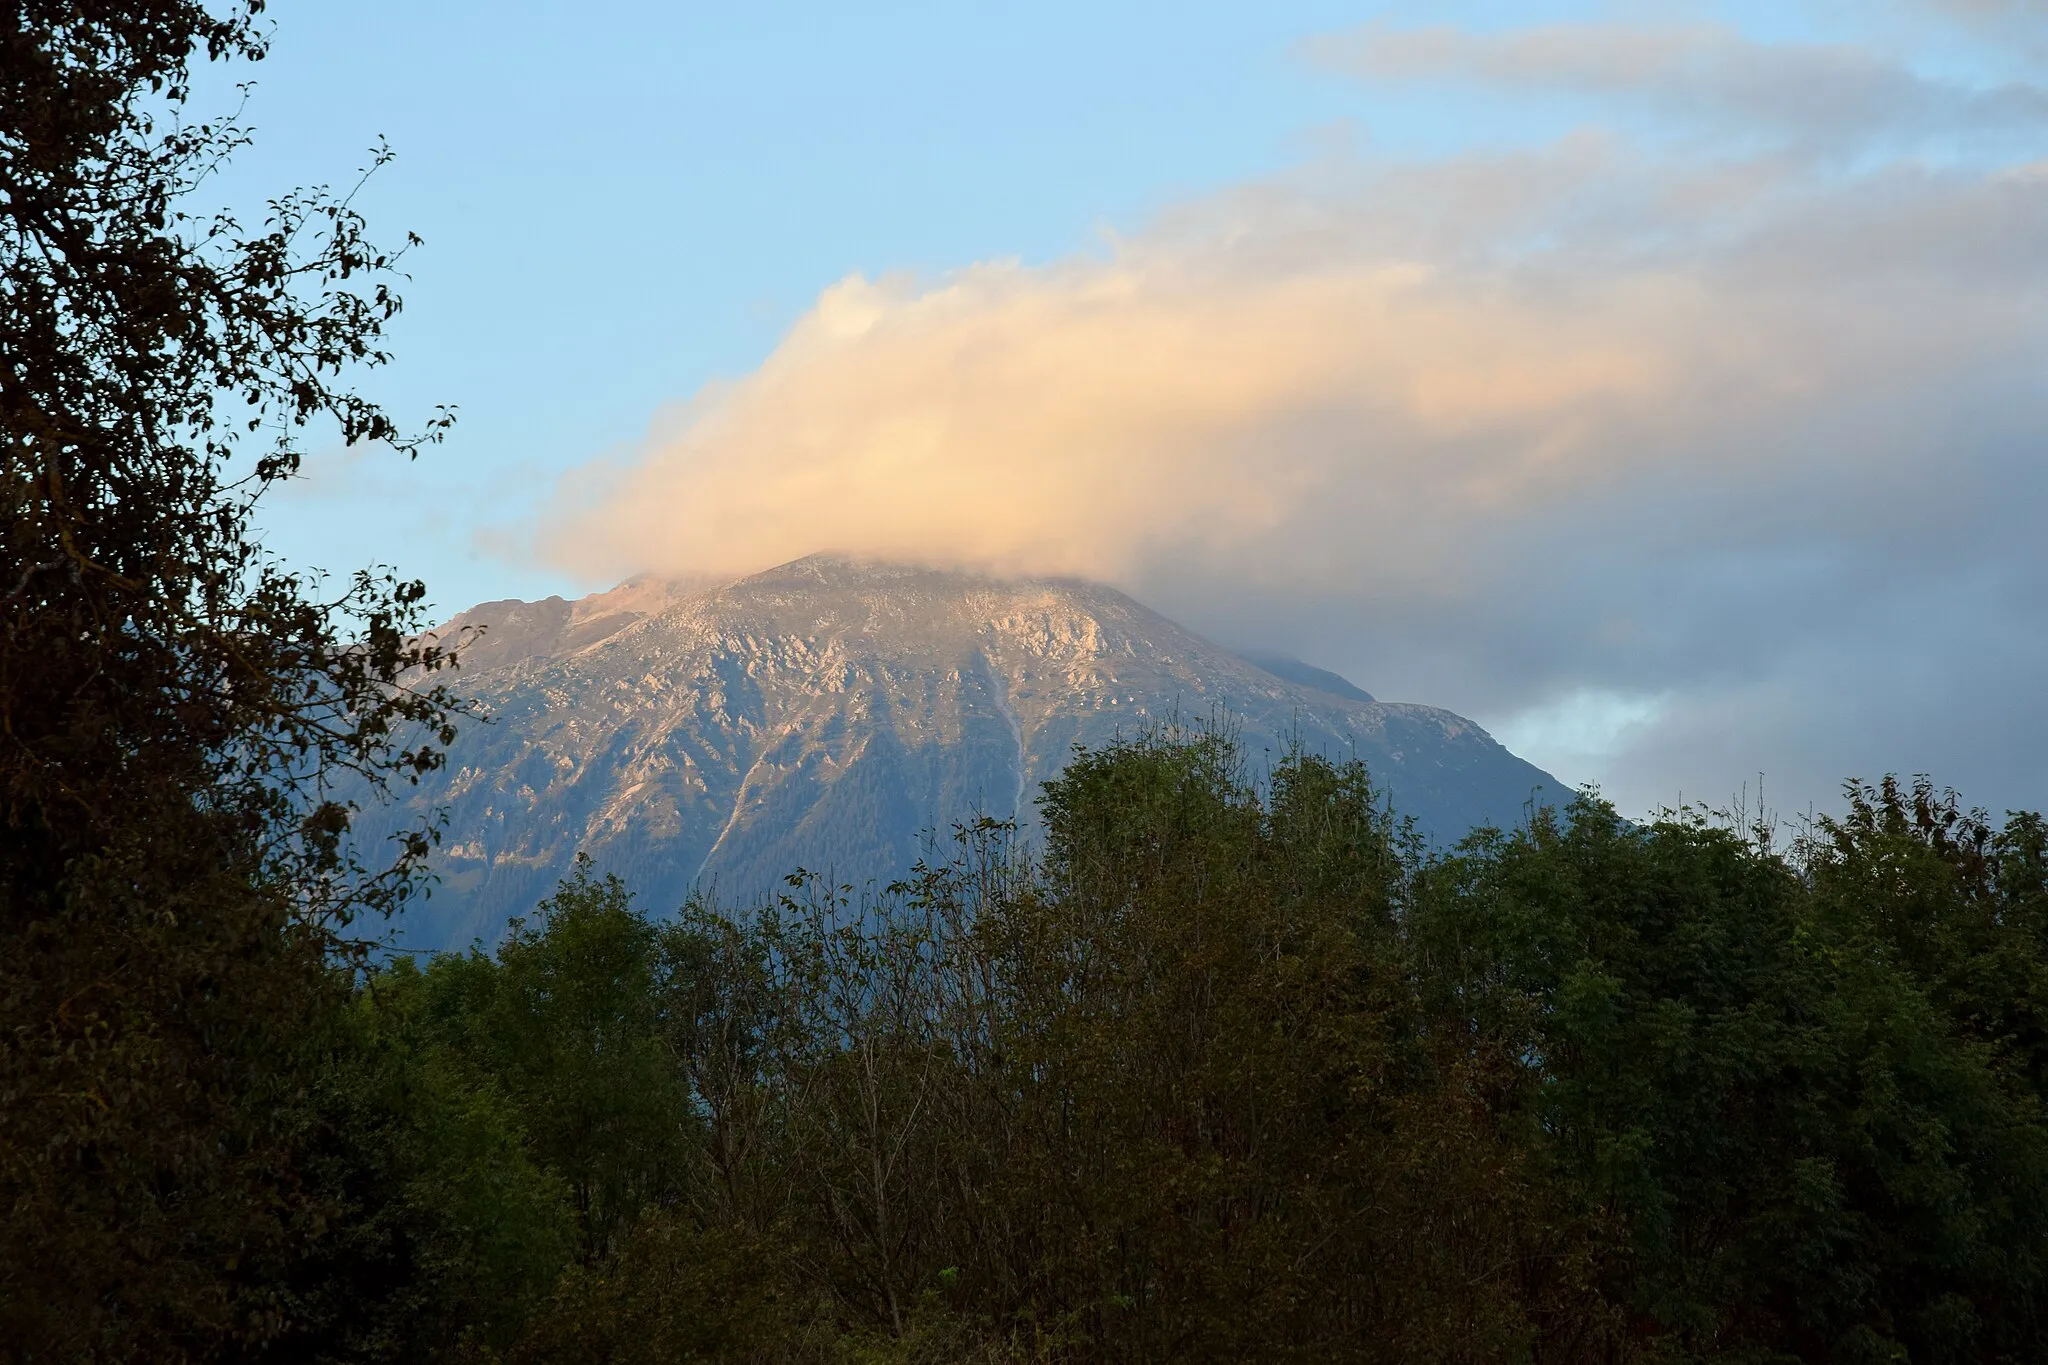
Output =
[{"x1": 1413, "y1": 784, "x2": 2048, "y2": 1361}]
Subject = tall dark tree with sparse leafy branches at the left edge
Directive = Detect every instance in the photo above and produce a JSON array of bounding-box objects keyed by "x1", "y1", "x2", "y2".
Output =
[{"x1": 0, "y1": 0, "x2": 461, "y2": 1359}]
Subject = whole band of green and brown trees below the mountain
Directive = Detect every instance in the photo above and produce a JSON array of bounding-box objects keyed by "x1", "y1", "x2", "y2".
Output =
[{"x1": 344, "y1": 731, "x2": 2048, "y2": 1363}]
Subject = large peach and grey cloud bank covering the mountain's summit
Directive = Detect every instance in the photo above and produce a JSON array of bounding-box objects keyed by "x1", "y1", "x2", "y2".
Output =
[{"x1": 543, "y1": 6, "x2": 2048, "y2": 808}]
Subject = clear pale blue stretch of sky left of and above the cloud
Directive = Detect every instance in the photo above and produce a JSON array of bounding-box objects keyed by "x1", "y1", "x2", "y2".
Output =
[{"x1": 223, "y1": 0, "x2": 1784, "y2": 610}]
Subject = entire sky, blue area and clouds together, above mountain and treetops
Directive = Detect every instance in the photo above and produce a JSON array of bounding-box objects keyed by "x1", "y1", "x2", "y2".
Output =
[{"x1": 228, "y1": 0, "x2": 2048, "y2": 812}]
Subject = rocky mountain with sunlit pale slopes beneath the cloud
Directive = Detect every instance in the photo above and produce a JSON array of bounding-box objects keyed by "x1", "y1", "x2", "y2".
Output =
[{"x1": 362, "y1": 555, "x2": 1563, "y2": 948}]
